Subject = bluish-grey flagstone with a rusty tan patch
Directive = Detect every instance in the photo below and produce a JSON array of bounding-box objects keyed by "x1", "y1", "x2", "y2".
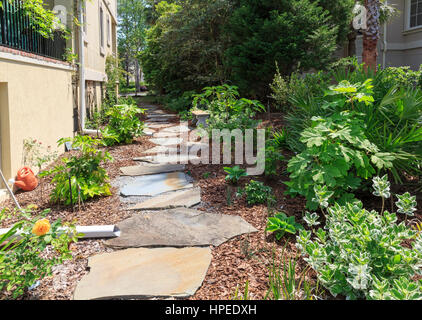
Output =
[{"x1": 120, "y1": 172, "x2": 193, "y2": 197}]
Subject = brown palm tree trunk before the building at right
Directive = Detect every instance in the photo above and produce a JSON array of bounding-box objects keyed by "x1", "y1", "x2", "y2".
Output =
[{"x1": 362, "y1": 0, "x2": 381, "y2": 72}]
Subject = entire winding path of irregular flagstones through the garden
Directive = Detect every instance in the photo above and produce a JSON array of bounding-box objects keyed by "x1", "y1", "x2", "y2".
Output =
[{"x1": 74, "y1": 105, "x2": 257, "y2": 300}]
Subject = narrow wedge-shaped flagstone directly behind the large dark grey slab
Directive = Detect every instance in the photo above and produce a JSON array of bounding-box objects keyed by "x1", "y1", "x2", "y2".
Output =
[{"x1": 129, "y1": 188, "x2": 201, "y2": 210}]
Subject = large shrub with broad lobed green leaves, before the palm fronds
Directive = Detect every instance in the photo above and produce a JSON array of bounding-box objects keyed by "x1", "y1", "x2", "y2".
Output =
[{"x1": 285, "y1": 112, "x2": 392, "y2": 210}]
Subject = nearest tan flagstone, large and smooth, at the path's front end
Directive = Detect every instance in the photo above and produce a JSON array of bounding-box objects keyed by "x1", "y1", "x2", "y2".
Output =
[{"x1": 73, "y1": 248, "x2": 212, "y2": 300}]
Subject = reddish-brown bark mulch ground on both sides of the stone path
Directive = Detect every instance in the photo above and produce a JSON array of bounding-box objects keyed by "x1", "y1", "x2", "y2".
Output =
[{"x1": 2, "y1": 99, "x2": 422, "y2": 300}]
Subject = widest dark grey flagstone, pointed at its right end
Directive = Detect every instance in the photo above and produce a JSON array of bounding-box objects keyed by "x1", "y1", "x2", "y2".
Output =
[{"x1": 105, "y1": 208, "x2": 258, "y2": 249}]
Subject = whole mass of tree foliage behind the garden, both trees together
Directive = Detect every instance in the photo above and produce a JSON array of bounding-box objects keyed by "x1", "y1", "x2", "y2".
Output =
[{"x1": 141, "y1": 0, "x2": 355, "y2": 97}]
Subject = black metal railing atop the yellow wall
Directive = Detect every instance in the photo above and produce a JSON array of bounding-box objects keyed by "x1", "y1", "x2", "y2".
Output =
[{"x1": 0, "y1": 0, "x2": 66, "y2": 60}]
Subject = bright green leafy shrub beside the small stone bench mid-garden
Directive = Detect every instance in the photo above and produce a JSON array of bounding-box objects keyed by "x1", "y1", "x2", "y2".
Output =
[{"x1": 193, "y1": 84, "x2": 265, "y2": 131}]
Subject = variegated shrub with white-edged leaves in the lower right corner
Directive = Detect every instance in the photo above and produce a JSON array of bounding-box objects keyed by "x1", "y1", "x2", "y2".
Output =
[{"x1": 297, "y1": 178, "x2": 422, "y2": 300}]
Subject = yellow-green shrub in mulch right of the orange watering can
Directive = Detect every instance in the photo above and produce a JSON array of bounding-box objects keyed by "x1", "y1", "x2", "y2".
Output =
[{"x1": 42, "y1": 136, "x2": 112, "y2": 205}]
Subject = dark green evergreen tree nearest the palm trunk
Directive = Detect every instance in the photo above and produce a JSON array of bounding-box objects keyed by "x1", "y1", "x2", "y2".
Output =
[{"x1": 225, "y1": 0, "x2": 352, "y2": 97}]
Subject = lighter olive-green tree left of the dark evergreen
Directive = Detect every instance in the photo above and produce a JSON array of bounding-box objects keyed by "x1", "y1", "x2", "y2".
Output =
[{"x1": 142, "y1": 0, "x2": 232, "y2": 94}]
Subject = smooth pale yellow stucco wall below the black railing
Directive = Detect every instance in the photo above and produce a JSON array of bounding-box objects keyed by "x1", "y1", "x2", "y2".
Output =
[{"x1": 0, "y1": 55, "x2": 74, "y2": 179}]
